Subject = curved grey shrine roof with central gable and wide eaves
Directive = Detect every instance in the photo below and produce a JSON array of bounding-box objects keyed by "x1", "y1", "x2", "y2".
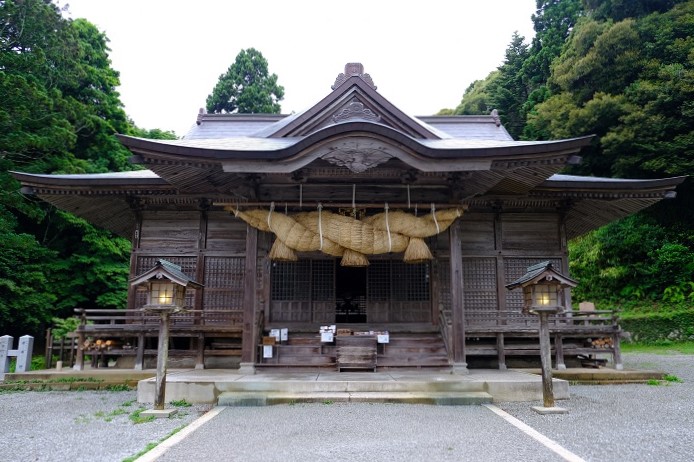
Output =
[{"x1": 8, "y1": 65, "x2": 684, "y2": 237}]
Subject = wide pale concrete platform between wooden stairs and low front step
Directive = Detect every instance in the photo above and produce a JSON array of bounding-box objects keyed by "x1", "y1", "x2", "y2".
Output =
[{"x1": 138, "y1": 370, "x2": 569, "y2": 405}]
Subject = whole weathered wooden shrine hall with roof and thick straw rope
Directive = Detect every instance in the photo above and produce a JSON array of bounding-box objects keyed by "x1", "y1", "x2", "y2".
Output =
[{"x1": 14, "y1": 63, "x2": 683, "y2": 370}]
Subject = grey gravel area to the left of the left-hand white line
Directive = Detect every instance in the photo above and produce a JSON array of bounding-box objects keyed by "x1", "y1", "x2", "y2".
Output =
[{"x1": 0, "y1": 391, "x2": 210, "y2": 462}]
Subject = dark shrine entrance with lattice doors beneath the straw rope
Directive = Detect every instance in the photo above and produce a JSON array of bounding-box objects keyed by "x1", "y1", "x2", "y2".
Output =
[{"x1": 268, "y1": 257, "x2": 432, "y2": 324}]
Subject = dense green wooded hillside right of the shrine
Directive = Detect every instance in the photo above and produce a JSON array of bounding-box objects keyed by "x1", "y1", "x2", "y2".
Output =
[{"x1": 455, "y1": 0, "x2": 694, "y2": 307}]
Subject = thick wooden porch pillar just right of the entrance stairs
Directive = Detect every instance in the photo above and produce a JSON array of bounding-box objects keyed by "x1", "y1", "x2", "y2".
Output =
[{"x1": 448, "y1": 220, "x2": 469, "y2": 373}]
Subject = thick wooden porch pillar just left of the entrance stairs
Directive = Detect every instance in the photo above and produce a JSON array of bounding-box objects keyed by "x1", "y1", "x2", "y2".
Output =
[{"x1": 241, "y1": 226, "x2": 258, "y2": 372}]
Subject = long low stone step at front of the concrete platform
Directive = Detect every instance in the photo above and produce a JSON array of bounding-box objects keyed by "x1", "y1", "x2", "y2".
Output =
[{"x1": 217, "y1": 391, "x2": 493, "y2": 406}]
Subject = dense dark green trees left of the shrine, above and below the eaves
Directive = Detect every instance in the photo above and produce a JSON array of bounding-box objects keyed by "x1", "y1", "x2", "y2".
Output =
[{"x1": 0, "y1": 0, "x2": 175, "y2": 335}]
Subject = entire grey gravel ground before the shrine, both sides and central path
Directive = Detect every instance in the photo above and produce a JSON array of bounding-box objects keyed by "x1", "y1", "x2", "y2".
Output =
[{"x1": 0, "y1": 354, "x2": 694, "y2": 462}]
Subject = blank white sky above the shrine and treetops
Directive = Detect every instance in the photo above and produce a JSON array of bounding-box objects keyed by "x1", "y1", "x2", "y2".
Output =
[{"x1": 60, "y1": 0, "x2": 535, "y2": 136}]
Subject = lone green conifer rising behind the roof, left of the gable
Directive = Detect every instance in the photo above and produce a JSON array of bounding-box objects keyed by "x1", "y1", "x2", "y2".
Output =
[{"x1": 207, "y1": 48, "x2": 284, "y2": 114}]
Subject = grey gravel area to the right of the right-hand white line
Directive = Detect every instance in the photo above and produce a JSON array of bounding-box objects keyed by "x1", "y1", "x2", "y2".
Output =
[{"x1": 499, "y1": 353, "x2": 694, "y2": 462}]
